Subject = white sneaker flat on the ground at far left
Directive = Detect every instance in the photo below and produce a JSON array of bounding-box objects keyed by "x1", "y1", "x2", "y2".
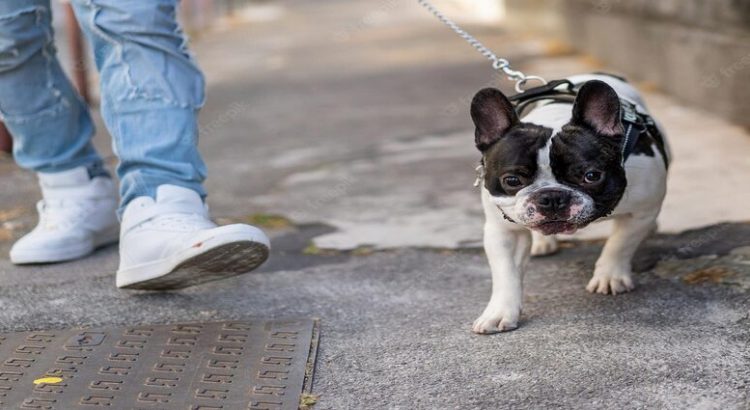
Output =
[{"x1": 10, "y1": 167, "x2": 119, "y2": 264}]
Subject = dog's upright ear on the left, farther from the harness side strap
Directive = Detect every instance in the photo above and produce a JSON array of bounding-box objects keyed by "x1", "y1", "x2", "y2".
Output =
[{"x1": 471, "y1": 88, "x2": 519, "y2": 152}]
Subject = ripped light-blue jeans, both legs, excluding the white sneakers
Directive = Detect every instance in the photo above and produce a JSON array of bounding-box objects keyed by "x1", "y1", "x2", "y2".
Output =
[{"x1": 0, "y1": 0, "x2": 206, "y2": 216}]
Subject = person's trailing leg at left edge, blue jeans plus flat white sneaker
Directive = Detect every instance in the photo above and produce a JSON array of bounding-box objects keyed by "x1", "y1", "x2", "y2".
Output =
[{"x1": 0, "y1": 0, "x2": 119, "y2": 264}]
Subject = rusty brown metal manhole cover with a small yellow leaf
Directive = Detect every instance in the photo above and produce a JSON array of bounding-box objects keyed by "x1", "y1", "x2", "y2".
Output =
[{"x1": 0, "y1": 319, "x2": 318, "y2": 410}]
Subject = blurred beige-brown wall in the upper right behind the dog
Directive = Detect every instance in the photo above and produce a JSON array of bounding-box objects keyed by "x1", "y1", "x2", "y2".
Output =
[{"x1": 505, "y1": 0, "x2": 750, "y2": 127}]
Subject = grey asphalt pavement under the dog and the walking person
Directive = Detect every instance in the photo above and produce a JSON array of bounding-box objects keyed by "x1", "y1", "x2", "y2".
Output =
[{"x1": 0, "y1": 0, "x2": 750, "y2": 409}]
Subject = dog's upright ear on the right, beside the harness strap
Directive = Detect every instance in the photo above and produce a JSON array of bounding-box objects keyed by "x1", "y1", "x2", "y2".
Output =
[{"x1": 572, "y1": 80, "x2": 625, "y2": 136}]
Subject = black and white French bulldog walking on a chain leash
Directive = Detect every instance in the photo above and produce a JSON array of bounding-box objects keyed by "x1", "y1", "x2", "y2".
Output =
[{"x1": 471, "y1": 74, "x2": 669, "y2": 333}]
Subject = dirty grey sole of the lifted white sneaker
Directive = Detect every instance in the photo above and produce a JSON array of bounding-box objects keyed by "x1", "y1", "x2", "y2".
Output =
[{"x1": 120, "y1": 240, "x2": 270, "y2": 291}]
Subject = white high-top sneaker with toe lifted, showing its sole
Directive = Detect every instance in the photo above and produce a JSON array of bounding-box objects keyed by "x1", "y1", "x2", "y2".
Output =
[{"x1": 117, "y1": 185, "x2": 270, "y2": 290}]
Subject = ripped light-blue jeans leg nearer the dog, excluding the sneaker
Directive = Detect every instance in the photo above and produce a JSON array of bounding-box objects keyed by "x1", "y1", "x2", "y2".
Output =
[{"x1": 73, "y1": 0, "x2": 206, "y2": 214}]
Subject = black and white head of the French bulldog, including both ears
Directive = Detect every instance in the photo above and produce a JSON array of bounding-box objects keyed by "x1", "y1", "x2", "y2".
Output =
[{"x1": 471, "y1": 81, "x2": 627, "y2": 235}]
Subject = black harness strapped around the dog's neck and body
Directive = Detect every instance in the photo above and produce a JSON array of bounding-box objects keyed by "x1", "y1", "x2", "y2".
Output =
[{"x1": 509, "y1": 80, "x2": 668, "y2": 163}]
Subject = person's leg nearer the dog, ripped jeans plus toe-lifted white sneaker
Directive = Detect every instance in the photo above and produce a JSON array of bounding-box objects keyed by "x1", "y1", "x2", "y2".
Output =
[{"x1": 74, "y1": 0, "x2": 270, "y2": 290}]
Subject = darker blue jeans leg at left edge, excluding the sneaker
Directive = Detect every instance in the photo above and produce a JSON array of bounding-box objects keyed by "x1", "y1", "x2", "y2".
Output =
[{"x1": 0, "y1": 0, "x2": 106, "y2": 177}]
